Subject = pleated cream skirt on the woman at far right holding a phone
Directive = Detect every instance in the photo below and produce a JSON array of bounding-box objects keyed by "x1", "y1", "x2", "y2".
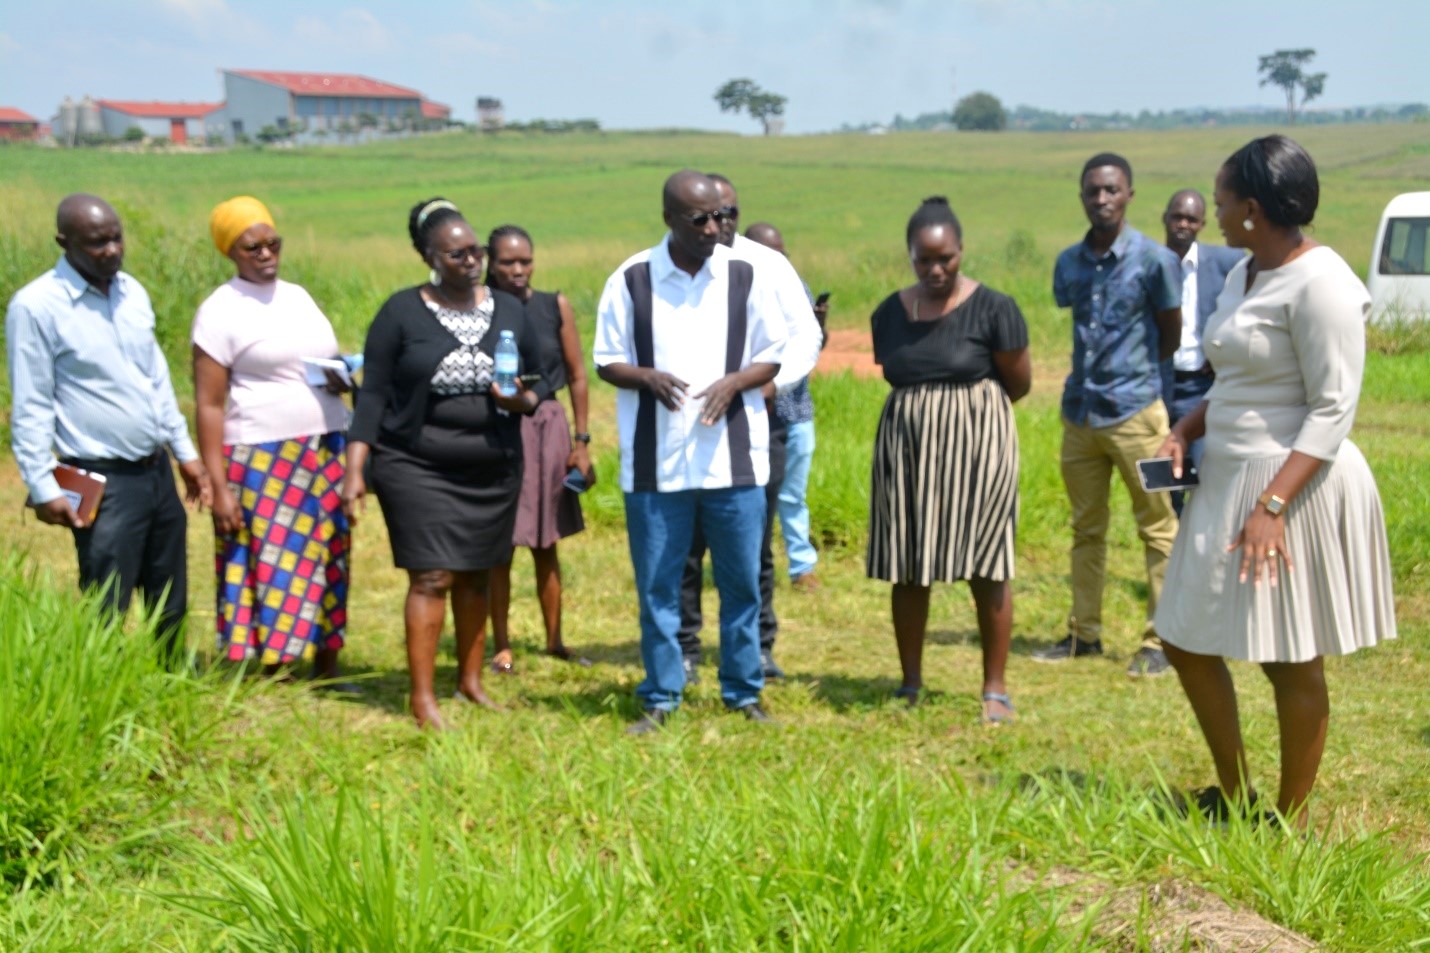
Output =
[{"x1": 1155, "y1": 441, "x2": 1396, "y2": 663}]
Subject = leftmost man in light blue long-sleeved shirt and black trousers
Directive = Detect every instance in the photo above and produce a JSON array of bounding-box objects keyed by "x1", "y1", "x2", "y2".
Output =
[{"x1": 6, "y1": 195, "x2": 212, "y2": 658}]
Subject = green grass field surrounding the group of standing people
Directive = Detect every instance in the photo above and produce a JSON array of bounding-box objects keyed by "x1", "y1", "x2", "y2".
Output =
[{"x1": 0, "y1": 126, "x2": 1430, "y2": 950}]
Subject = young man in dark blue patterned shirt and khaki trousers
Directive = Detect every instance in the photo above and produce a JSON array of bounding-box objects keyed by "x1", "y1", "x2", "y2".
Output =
[{"x1": 1034, "y1": 153, "x2": 1181, "y2": 677}]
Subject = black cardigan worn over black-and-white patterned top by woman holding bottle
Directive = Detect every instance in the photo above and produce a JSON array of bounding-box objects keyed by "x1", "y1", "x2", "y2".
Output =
[{"x1": 347, "y1": 288, "x2": 551, "y2": 449}]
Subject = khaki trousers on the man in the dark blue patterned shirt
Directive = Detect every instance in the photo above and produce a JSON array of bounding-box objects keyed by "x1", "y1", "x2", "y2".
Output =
[{"x1": 1061, "y1": 401, "x2": 1177, "y2": 645}]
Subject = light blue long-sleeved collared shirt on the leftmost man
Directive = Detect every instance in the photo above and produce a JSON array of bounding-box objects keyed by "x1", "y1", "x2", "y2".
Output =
[{"x1": 4, "y1": 258, "x2": 199, "y2": 504}]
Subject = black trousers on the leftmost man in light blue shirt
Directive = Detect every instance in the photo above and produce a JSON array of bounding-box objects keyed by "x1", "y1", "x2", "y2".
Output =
[{"x1": 64, "y1": 451, "x2": 189, "y2": 660}]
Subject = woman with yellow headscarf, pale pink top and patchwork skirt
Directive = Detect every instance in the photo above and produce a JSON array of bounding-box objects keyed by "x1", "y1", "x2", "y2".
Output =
[{"x1": 193, "y1": 196, "x2": 350, "y2": 691}]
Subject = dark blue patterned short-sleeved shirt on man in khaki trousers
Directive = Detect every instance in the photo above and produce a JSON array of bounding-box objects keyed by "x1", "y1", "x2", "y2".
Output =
[{"x1": 1052, "y1": 225, "x2": 1181, "y2": 426}]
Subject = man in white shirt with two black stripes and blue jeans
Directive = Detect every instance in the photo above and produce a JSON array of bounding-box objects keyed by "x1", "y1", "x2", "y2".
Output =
[{"x1": 592, "y1": 169, "x2": 788, "y2": 734}]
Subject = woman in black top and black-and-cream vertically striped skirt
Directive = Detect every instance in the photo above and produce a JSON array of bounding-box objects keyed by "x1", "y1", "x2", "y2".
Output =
[{"x1": 868, "y1": 196, "x2": 1032, "y2": 724}]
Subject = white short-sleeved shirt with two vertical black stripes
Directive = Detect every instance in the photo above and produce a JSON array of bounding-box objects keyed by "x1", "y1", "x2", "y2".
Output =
[{"x1": 591, "y1": 236, "x2": 789, "y2": 492}]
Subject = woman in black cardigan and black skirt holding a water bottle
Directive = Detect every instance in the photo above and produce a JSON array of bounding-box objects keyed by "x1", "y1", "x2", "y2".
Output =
[{"x1": 343, "y1": 199, "x2": 546, "y2": 728}]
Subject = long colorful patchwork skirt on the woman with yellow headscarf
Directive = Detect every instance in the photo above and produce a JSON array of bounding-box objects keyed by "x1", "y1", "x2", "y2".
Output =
[{"x1": 215, "y1": 432, "x2": 352, "y2": 665}]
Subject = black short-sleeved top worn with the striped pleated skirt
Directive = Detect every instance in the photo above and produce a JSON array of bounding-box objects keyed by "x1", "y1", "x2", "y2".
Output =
[{"x1": 869, "y1": 285, "x2": 1028, "y2": 388}]
